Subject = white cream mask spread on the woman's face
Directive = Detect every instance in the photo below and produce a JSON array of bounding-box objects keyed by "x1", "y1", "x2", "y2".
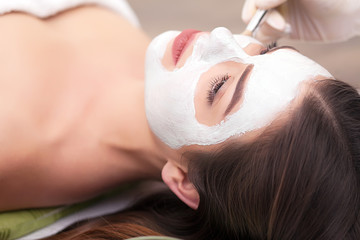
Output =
[{"x1": 145, "y1": 28, "x2": 333, "y2": 149}]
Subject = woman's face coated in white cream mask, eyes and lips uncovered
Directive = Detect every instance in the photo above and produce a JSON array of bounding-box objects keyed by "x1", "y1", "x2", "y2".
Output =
[{"x1": 145, "y1": 28, "x2": 332, "y2": 149}]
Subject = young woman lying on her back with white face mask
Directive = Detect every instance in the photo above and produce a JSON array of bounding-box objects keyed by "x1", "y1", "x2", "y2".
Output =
[{"x1": 0, "y1": 0, "x2": 360, "y2": 239}]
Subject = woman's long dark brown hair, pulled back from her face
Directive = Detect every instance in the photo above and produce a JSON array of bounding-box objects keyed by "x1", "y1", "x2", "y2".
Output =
[{"x1": 47, "y1": 80, "x2": 360, "y2": 240}]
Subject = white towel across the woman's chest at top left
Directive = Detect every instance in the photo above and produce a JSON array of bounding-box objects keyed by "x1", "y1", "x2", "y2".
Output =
[{"x1": 0, "y1": 0, "x2": 140, "y2": 27}]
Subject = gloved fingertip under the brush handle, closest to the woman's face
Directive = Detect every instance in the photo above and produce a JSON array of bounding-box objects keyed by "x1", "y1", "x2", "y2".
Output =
[{"x1": 254, "y1": 10, "x2": 289, "y2": 43}]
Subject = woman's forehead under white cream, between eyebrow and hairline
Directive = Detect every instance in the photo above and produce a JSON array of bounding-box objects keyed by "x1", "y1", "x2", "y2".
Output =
[{"x1": 231, "y1": 49, "x2": 329, "y2": 117}]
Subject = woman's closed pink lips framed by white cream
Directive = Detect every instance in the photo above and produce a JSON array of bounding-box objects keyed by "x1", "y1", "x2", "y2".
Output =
[{"x1": 172, "y1": 29, "x2": 200, "y2": 65}]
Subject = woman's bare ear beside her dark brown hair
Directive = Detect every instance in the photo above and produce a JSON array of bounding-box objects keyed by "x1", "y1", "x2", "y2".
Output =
[{"x1": 162, "y1": 161, "x2": 200, "y2": 209}]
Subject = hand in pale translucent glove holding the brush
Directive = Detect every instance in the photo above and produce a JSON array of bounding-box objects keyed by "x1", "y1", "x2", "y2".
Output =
[{"x1": 242, "y1": 0, "x2": 360, "y2": 42}]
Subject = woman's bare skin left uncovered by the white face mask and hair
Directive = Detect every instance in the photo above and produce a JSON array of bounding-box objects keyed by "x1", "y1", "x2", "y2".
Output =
[{"x1": 0, "y1": 6, "x2": 330, "y2": 211}]
